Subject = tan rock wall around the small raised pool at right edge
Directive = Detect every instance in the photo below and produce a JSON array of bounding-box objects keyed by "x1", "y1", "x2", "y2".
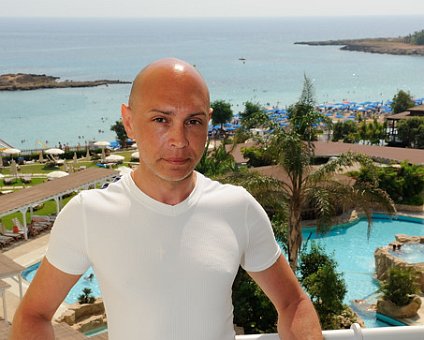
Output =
[{"x1": 374, "y1": 234, "x2": 424, "y2": 293}]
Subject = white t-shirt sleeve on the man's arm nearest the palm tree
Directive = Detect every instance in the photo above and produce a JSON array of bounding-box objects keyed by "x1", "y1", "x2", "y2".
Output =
[{"x1": 241, "y1": 194, "x2": 281, "y2": 272}]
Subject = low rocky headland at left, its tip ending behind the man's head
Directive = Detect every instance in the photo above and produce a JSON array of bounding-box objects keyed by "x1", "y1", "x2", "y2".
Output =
[{"x1": 0, "y1": 73, "x2": 131, "y2": 91}]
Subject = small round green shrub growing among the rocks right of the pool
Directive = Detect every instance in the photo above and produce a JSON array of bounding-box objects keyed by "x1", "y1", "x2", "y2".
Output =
[{"x1": 380, "y1": 267, "x2": 417, "y2": 306}]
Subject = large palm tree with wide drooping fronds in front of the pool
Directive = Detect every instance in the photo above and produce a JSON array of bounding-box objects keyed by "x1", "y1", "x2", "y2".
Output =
[{"x1": 220, "y1": 131, "x2": 396, "y2": 271}]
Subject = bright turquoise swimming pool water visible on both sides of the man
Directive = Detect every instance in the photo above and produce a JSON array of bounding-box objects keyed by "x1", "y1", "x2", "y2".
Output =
[{"x1": 23, "y1": 215, "x2": 424, "y2": 327}]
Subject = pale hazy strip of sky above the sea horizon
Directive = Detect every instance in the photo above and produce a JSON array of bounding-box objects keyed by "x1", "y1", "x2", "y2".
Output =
[{"x1": 0, "y1": 0, "x2": 424, "y2": 17}]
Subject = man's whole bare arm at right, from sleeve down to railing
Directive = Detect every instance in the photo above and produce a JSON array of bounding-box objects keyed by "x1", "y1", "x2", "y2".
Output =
[{"x1": 249, "y1": 256, "x2": 322, "y2": 340}]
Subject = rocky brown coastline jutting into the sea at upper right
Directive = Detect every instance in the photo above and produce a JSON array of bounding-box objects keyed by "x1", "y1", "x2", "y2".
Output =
[{"x1": 295, "y1": 38, "x2": 424, "y2": 56}]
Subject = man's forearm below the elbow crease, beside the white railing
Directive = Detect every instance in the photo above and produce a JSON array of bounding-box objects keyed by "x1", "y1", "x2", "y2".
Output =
[{"x1": 278, "y1": 297, "x2": 322, "y2": 340}]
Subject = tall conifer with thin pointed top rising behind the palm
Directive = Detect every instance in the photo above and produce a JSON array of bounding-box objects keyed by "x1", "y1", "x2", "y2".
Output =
[{"x1": 287, "y1": 75, "x2": 331, "y2": 143}]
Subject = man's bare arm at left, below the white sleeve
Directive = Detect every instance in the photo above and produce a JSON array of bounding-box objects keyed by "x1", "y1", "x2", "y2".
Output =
[{"x1": 10, "y1": 258, "x2": 81, "y2": 340}]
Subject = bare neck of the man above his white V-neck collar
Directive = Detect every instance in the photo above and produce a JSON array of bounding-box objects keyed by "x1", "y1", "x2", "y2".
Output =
[{"x1": 131, "y1": 168, "x2": 196, "y2": 205}]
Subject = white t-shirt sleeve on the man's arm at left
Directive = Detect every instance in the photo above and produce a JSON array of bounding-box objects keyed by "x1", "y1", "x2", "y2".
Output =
[{"x1": 46, "y1": 194, "x2": 90, "y2": 275}]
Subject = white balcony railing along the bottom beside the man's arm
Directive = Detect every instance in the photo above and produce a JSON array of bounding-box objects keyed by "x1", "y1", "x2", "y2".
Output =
[{"x1": 236, "y1": 323, "x2": 424, "y2": 340}]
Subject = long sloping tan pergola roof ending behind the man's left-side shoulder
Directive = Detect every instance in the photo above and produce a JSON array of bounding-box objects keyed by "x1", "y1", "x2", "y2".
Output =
[{"x1": 0, "y1": 168, "x2": 118, "y2": 216}]
